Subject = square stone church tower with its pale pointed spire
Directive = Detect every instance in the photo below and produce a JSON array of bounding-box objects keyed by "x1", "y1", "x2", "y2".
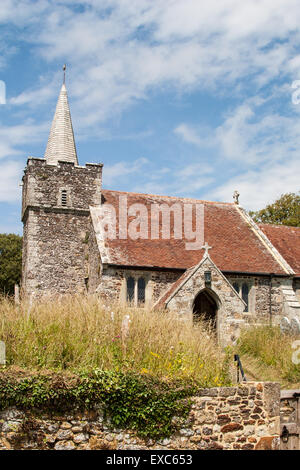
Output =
[{"x1": 21, "y1": 70, "x2": 103, "y2": 296}]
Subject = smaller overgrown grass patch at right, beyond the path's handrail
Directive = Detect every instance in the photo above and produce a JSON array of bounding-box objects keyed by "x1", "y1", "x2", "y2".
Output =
[{"x1": 237, "y1": 326, "x2": 300, "y2": 388}]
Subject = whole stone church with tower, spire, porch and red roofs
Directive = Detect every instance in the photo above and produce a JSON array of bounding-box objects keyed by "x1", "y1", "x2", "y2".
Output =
[{"x1": 21, "y1": 84, "x2": 300, "y2": 344}]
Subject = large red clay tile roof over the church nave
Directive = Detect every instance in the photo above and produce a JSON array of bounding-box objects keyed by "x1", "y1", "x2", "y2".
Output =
[{"x1": 102, "y1": 190, "x2": 286, "y2": 274}]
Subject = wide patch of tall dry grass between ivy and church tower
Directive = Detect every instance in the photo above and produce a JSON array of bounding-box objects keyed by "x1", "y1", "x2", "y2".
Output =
[{"x1": 0, "y1": 296, "x2": 229, "y2": 386}]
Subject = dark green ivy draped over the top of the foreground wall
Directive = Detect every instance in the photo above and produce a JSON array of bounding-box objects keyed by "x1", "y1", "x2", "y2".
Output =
[{"x1": 0, "y1": 370, "x2": 195, "y2": 438}]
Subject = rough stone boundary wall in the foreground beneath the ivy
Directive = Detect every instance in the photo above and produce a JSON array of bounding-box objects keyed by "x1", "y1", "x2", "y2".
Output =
[{"x1": 0, "y1": 382, "x2": 280, "y2": 450}]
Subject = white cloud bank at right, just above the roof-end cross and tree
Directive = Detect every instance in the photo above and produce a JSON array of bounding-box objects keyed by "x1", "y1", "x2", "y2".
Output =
[{"x1": 177, "y1": 97, "x2": 300, "y2": 210}]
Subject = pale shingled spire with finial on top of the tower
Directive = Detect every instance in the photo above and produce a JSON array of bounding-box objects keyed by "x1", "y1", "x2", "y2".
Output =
[{"x1": 45, "y1": 66, "x2": 78, "y2": 165}]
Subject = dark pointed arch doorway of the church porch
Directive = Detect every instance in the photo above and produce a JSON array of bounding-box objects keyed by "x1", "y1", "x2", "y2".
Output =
[{"x1": 193, "y1": 289, "x2": 218, "y2": 332}]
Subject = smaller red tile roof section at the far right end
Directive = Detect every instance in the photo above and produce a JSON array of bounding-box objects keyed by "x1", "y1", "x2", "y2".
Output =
[{"x1": 259, "y1": 224, "x2": 300, "y2": 276}]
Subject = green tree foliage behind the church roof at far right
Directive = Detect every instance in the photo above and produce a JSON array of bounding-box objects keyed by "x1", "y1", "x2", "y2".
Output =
[{"x1": 249, "y1": 193, "x2": 300, "y2": 227}]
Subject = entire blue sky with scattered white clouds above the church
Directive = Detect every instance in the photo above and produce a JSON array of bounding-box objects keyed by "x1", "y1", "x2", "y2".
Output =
[{"x1": 0, "y1": 0, "x2": 300, "y2": 233}]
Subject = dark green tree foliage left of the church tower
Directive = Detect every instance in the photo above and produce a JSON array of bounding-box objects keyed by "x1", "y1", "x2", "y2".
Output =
[{"x1": 0, "y1": 233, "x2": 22, "y2": 294}]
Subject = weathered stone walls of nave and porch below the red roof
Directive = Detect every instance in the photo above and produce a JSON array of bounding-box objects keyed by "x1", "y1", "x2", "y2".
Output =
[{"x1": 89, "y1": 258, "x2": 294, "y2": 343}]
